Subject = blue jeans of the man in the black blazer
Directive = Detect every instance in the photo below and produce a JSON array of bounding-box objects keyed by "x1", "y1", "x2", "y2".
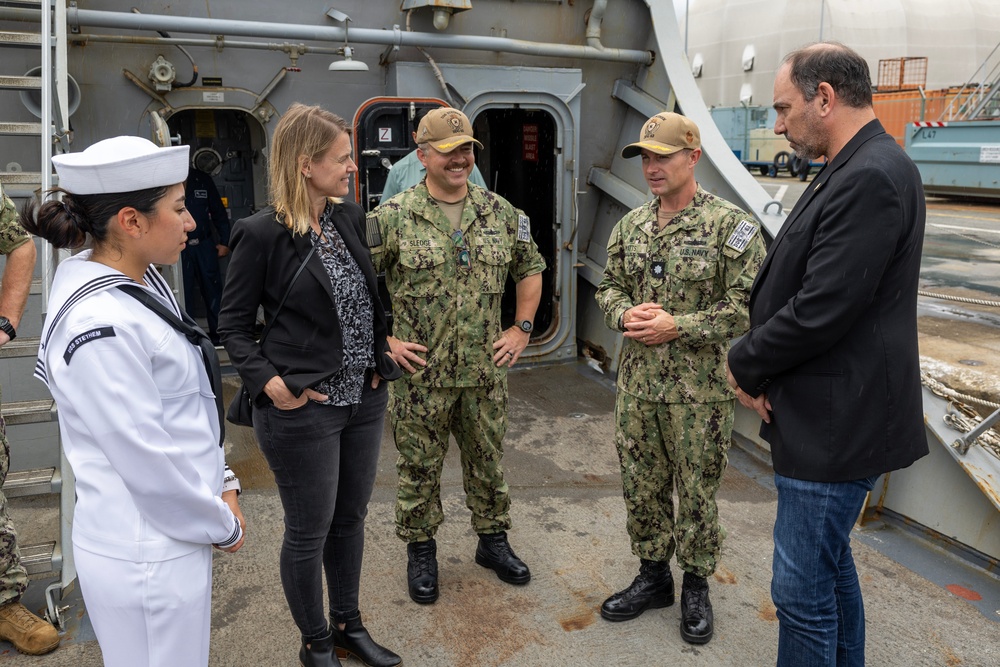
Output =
[{"x1": 771, "y1": 473, "x2": 877, "y2": 667}]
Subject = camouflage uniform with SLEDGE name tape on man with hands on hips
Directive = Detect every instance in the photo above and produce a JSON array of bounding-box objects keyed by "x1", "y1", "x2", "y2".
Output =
[{"x1": 368, "y1": 183, "x2": 545, "y2": 542}]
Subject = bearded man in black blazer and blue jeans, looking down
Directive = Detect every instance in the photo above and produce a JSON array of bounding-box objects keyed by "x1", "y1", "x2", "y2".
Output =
[{"x1": 728, "y1": 43, "x2": 927, "y2": 667}]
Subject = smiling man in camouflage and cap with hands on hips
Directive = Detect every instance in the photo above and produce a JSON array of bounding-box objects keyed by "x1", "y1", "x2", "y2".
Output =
[{"x1": 367, "y1": 108, "x2": 545, "y2": 604}]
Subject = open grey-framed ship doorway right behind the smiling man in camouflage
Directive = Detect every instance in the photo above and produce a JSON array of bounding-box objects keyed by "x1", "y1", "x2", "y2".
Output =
[{"x1": 378, "y1": 62, "x2": 584, "y2": 362}]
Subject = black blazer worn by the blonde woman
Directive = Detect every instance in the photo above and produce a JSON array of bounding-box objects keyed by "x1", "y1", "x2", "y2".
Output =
[{"x1": 219, "y1": 202, "x2": 401, "y2": 405}]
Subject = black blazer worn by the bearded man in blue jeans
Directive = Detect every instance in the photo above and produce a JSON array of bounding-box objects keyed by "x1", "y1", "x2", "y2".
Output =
[{"x1": 729, "y1": 120, "x2": 927, "y2": 482}]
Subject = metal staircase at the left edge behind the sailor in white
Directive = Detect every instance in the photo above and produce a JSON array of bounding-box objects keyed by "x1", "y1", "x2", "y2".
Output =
[{"x1": 0, "y1": 0, "x2": 76, "y2": 626}]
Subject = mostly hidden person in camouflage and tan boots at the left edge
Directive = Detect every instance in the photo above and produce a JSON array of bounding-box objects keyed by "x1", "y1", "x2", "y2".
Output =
[{"x1": 0, "y1": 183, "x2": 59, "y2": 655}]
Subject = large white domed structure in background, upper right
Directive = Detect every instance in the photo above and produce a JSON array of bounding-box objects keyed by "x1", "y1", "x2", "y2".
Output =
[{"x1": 674, "y1": 0, "x2": 1000, "y2": 106}]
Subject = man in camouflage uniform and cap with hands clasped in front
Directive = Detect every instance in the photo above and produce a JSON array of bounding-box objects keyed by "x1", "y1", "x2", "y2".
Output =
[{"x1": 597, "y1": 112, "x2": 764, "y2": 644}]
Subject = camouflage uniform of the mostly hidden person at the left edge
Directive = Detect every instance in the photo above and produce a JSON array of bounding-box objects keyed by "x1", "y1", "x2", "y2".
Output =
[{"x1": 0, "y1": 184, "x2": 31, "y2": 606}]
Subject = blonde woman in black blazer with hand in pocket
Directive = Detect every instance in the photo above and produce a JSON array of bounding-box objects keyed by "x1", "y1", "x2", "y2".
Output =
[{"x1": 219, "y1": 104, "x2": 402, "y2": 667}]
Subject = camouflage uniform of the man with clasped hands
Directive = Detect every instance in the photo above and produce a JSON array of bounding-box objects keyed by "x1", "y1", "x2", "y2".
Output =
[{"x1": 597, "y1": 187, "x2": 764, "y2": 577}]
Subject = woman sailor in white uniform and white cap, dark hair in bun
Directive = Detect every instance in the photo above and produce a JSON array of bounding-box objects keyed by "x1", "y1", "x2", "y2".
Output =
[{"x1": 22, "y1": 137, "x2": 243, "y2": 667}]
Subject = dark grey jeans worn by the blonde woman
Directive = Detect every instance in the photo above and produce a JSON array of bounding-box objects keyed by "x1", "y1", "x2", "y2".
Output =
[{"x1": 253, "y1": 379, "x2": 389, "y2": 640}]
